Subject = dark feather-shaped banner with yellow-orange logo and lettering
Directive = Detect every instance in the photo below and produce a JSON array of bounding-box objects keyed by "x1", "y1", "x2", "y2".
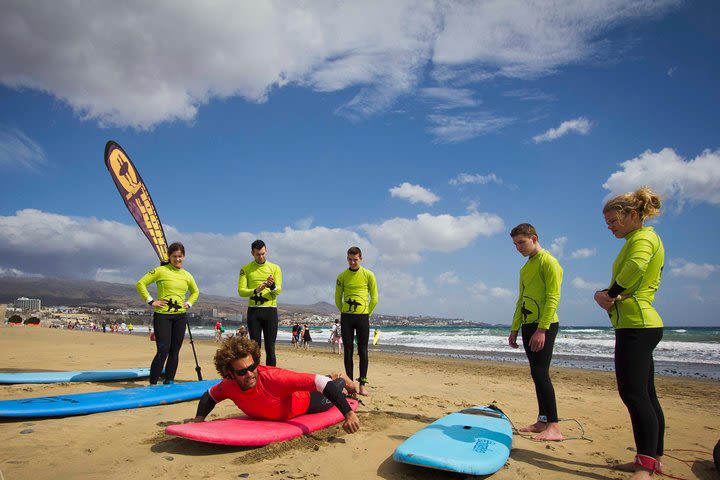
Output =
[{"x1": 105, "y1": 140, "x2": 168, "y2": 262}]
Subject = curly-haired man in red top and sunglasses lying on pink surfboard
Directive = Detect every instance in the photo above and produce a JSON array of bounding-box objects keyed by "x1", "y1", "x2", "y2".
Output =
[{"x1": 193, "y1": 337, "x2": 360, "y2": 433}]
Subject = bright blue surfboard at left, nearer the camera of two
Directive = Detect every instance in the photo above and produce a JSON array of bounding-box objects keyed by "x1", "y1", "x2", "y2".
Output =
[{"x1": 0, "y1": 380, "x2": 220, "y2": 417}]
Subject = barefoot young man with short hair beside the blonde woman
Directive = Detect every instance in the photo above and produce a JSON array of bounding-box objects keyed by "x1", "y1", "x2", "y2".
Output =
[{"x1": 508, "y1": 223, "x2": 563, "y2": 440}]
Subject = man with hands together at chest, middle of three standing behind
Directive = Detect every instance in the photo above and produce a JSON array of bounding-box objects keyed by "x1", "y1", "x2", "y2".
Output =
[{"x1": 238, "y1": 240, "x2": 282, "y2": 367}]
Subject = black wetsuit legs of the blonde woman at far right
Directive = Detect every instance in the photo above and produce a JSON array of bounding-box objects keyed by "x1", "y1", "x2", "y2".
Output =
[{"x1": 615, "y1": 327, "x2": 665, "y2": 457}]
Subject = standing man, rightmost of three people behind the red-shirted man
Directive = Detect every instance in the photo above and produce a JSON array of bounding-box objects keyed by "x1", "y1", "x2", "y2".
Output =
[{"x1": 335, "y1": 247, "x2": 378, "y2": 395}]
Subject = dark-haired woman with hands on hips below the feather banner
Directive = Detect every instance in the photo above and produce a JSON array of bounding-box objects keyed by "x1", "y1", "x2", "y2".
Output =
[{"x1": 135, "y1": 242, "x2": 200, "y2": 385}]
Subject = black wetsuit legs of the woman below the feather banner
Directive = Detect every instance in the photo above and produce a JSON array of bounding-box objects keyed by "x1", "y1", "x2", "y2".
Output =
[{"x1": 150, "y1": 312, "x2": 187, "y2": 385}]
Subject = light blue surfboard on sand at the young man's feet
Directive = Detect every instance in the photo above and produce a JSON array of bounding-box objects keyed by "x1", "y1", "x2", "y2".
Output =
[{"x1": 393, "y1": 406, "x2": 512, "y2": 475}]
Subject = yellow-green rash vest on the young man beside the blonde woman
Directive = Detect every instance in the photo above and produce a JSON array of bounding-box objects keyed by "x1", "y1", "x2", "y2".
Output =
[{"x1": 510, "y1": 250, "x2": 563, "y2": 331}]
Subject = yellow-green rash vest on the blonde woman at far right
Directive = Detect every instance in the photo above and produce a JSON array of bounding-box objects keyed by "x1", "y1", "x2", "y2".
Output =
[{"x1": 610, "y1": 227, "x2": 665, "y2": 328}]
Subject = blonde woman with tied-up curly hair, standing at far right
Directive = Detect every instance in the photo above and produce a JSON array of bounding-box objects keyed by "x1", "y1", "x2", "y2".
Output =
[{"x1": 595, "y1": 187, "x2": 665, "y2": 480}]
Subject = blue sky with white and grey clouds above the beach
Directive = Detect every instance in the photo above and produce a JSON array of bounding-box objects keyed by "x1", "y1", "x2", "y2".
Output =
[{"x1": 0, "y1": 0, "x2": 720, "y2": 326}]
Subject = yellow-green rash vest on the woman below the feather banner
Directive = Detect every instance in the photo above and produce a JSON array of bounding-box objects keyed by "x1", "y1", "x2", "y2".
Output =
[{"x1": 135, "y1": 264, "x2": 200, "y2": 314}]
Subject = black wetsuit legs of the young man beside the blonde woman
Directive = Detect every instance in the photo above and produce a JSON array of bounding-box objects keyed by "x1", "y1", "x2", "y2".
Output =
[{"x1": 522, "y1": 322, "x2": 559, "y2": 423}]
